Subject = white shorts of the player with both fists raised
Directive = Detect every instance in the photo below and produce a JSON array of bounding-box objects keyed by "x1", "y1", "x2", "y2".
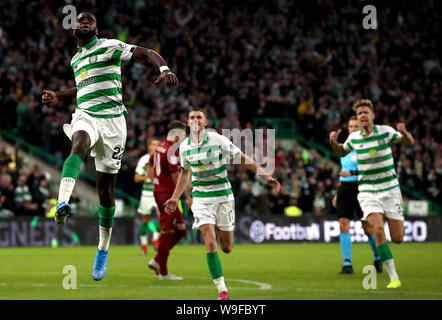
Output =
[{"x1": 358, "y1": 188, "x2": 404, "y2": 221}]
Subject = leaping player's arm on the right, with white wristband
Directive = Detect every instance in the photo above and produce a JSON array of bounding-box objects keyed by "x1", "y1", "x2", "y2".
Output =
[{"x1": 132, "y1": 47, "x2": 178, "y2": 86}]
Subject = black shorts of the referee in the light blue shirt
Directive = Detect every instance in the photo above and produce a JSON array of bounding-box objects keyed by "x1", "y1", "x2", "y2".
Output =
[{"x1": 336, "y1": 181, "x2": 363, "y2": 220}]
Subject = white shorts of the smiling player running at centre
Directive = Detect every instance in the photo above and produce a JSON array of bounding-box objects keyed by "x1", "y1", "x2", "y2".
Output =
[{"x1": 192, "y1": 199, "x2": 235, "y2": 231}]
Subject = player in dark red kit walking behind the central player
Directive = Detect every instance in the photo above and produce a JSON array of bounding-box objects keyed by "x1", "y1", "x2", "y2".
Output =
[{"x1": 147, "y1": 120, "x2": 192, "y2": 280}]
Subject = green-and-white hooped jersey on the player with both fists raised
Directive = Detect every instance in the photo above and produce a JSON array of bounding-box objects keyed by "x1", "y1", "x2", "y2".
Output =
[{"x1": 344, "y1": 125, "x2": 402, "y2": 192}]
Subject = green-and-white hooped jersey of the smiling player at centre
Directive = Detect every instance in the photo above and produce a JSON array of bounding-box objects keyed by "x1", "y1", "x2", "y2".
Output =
[{"x1": 180, "y1": 130, "x2": 241, "y2": 203}]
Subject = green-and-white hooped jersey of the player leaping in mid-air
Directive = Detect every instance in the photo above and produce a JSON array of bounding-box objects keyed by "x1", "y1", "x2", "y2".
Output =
[{"x1": 71, "y1": 38, "x2": 136, "y2": 118}]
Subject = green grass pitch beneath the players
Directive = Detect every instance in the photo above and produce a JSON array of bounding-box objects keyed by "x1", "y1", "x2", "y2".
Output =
[{"x1": 0, "y1": 243, "x2": 442, "y2": 300}]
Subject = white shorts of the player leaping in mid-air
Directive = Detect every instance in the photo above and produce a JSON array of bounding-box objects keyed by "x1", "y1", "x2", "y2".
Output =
[{"x1": 63, "y1": 111, "x2": 127, "y2": 174}]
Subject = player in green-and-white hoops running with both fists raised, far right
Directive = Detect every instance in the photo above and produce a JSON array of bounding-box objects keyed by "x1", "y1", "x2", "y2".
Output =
[{"x1": 330, "y1": 99, "x2": 414, "y2": 288}]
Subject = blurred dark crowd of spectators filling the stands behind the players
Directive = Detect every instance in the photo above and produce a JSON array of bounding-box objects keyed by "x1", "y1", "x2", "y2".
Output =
[{"x1": 0, "y1": 0, "x2": 442, "y2": 216}]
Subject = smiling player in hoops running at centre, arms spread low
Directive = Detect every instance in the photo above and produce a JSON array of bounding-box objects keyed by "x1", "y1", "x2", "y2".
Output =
[{"x1": 165, "y1": 108, "x2": 281, "y2": 300}]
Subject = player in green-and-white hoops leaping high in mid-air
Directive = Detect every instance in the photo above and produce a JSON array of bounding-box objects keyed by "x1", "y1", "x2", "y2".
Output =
[{"x1": 42, "y1": 12, "x2": 178, "y2": 280}]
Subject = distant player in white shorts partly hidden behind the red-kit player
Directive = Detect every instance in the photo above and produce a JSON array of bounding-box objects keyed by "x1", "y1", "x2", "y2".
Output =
[{"x1": 134, "y1": 138, "x2": 160, "y2": 254}]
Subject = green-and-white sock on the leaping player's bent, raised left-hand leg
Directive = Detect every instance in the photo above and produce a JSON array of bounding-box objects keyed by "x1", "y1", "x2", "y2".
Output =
[{"x1": 58, "y1": 154, "x2": 82, "y2": 203}]
